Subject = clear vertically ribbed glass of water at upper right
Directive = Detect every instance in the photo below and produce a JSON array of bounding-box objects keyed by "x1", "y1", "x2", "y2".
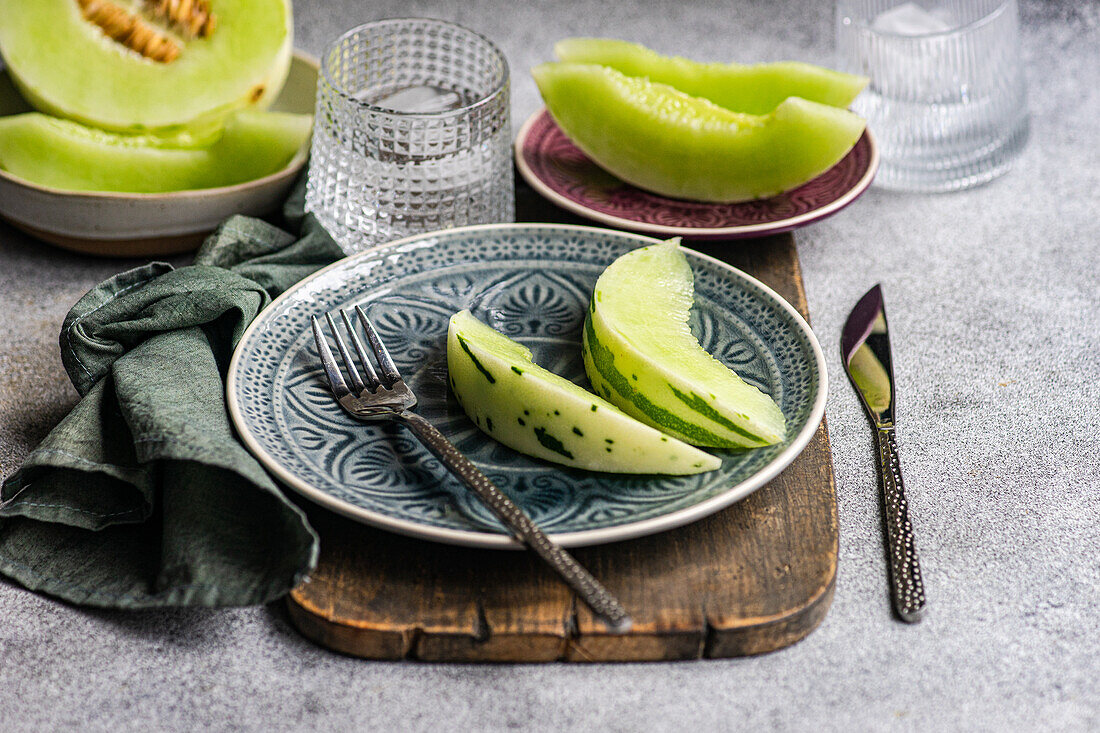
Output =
[{"x1": 836, "y1": 0, "x2": 1029, "y2": 192}]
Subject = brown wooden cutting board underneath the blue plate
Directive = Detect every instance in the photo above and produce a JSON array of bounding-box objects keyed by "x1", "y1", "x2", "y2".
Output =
[{"x1": 287, "y1": 179, "x2": 837, "y2": 661}]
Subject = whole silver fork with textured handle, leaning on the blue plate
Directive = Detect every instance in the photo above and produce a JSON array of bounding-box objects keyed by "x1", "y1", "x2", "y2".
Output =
[{"x1": 310, "y1": 306, "x2": 633, "y2": 633}]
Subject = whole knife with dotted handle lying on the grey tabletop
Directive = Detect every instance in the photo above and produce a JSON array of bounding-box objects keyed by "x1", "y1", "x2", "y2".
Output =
[{"x1": 840, "y1": 285, "x2": 925, "y2": 623}]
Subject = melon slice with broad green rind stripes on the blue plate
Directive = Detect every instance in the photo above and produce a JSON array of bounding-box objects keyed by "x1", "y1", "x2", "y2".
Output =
[{"x1": 583, "y1": 240, "x2": 785, "y2": 448}]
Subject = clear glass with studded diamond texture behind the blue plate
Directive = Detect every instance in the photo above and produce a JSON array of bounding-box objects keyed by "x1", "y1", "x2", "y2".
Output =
[{"x1": 306, "y1": 19, "x2": 515, "y2": 254}]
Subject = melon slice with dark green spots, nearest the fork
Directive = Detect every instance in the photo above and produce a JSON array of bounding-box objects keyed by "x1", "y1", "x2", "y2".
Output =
[{"x1": 447, "y1": 310, "x2": 722, "y2": 475}]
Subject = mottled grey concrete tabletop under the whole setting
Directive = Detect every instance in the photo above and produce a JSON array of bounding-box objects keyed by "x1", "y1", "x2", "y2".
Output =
[{"x1": 0, "y1": 0, "x2": 1100, "y2": 732}]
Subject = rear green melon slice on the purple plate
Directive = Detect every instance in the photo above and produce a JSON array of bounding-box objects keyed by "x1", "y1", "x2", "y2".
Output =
[{"x1": 553, "y1": 39, "x2": 868, "y2": 114}]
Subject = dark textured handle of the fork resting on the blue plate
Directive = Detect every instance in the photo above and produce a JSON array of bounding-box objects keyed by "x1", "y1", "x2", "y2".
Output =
[{"x1": 398, "y1": 413, "x2": 633, "y2": 633}]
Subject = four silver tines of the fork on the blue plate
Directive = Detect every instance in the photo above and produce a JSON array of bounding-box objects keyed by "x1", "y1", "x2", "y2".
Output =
[{"x1": 309, "y1": 306, "x2": 402, "y2": 400}]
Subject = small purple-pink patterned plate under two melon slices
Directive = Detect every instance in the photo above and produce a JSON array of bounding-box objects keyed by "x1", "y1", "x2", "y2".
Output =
[{"x1": 516, "y1": 109, "x2": 879, "y2": 239}]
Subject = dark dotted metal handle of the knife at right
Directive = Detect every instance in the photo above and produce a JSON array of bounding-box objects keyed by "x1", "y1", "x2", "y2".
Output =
[{"x1": 875, "y1": 427, "x2": 924, "y2": 624}]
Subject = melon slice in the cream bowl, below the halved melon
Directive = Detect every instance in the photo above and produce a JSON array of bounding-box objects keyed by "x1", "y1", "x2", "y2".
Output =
[{"x1": 0, "y1": 111, "x2": 312, "y2": 194}]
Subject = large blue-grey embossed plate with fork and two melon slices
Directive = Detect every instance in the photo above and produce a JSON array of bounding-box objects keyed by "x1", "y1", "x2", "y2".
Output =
[{"x1": 228, "y1": 225, "x2": 826, "y2": 548}]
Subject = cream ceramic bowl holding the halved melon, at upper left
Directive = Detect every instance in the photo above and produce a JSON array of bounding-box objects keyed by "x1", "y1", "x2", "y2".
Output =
[{"x1": 0, "y1": 52, "x2": 318, "y2": 256}]
